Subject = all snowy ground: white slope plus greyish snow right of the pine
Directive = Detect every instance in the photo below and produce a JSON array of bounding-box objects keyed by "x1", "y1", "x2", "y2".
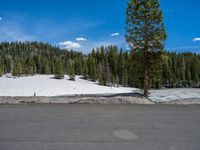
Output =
[{"x1": 0, "y1": 75, "x2": 200, "y2": 102}]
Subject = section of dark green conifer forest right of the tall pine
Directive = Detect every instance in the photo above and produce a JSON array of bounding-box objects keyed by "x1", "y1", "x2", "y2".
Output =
[{"x1": 161, "y1": 52, "x2": 200, "y2": 87}]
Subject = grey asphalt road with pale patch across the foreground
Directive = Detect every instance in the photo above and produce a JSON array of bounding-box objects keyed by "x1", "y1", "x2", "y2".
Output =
[{"x1": 0, "y1": 104, "x2": 200, "y2": 150}]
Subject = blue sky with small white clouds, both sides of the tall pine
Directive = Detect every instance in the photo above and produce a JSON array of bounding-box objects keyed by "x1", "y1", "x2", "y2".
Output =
[{"x1": 0, "y1": 0, "x2": 200, "y2": 52}]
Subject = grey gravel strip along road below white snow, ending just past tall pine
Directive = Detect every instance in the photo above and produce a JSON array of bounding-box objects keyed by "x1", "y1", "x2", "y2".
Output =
[{"x1": 0, "y1": 94, "x2": 155, "y2": 104}]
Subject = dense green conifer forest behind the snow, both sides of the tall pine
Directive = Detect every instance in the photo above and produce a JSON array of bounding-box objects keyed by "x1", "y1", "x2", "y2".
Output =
[{"x1": 0, "y1": 42, "x2": 200, "y2": 88}]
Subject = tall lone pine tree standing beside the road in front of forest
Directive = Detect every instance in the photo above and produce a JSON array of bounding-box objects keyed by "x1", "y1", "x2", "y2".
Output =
[{"x1": 125, "y1": 0, "x2": 166, "y2": 97}]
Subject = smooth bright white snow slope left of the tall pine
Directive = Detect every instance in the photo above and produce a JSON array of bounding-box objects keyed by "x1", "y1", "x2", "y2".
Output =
[{"x1": 0, "y1": 75, "x2": 134, "y2": 96}]
